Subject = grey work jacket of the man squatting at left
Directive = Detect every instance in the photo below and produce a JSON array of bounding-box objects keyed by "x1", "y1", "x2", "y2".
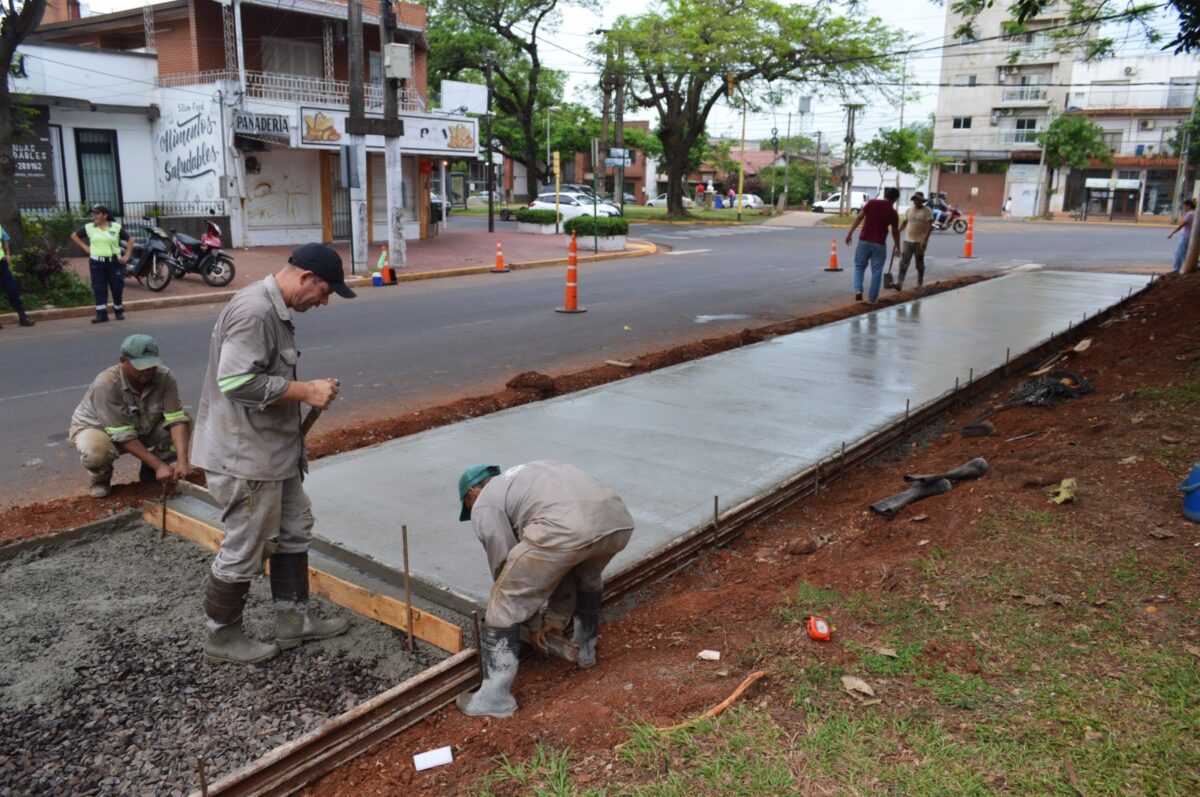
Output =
[{"x1": 67, "y1": 365, "x2": 187, "y2": 445}]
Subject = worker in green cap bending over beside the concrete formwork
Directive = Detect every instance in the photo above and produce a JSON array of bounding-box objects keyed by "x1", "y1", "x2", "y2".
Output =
[{"x1": 457, "y1": 460, "x2": 634, "y2": 717}]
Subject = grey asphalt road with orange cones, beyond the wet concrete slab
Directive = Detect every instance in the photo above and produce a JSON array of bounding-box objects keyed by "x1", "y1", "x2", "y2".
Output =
[{"x1": 0, "y1": 217, "x2": 1171, "y2": 504}]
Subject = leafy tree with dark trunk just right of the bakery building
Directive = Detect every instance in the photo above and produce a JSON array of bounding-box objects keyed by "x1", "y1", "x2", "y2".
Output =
[{"x1": 430, "y1": 0, "x2": 594, "y2": 196}]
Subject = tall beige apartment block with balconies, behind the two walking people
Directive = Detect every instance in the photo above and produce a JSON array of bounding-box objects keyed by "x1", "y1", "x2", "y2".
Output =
[{"x1": 930, "y1": 1, "x2": 1094, "y2": 215}]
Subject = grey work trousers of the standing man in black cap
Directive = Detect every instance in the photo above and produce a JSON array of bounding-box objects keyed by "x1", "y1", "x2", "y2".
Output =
[{"x1": 205, "y1": 471, "x2": 314, "y2": 583}]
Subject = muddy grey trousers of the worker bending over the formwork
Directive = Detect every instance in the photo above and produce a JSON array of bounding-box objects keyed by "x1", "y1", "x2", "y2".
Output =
[{"x1": 485, "y1": 528, "x2": 634, "y2": 629}]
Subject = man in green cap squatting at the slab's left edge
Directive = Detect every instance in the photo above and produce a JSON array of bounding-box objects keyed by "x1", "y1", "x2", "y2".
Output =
[{"x1": 67, "y1": 335, "x2": 191, "y2": 498}]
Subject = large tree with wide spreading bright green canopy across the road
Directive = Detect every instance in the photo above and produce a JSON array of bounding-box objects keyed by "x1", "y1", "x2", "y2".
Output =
[{"x1": 609, "y1": 0, "x2": 900, "y2": 215}]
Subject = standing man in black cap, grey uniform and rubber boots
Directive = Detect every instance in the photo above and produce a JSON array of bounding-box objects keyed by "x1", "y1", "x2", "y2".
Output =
[{"x1": 193, "y1": 244, "x2": 355, "y2": 664}]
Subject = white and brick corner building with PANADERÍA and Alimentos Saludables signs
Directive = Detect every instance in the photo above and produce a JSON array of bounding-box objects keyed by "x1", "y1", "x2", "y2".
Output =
[{"x1": 32, "y1": 0, "x2": 479, "y2": 246}]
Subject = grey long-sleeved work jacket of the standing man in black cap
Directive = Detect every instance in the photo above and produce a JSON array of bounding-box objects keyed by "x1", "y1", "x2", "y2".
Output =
[{"x1": 192, "y1": 276, "x2": 304, "y2": 481}]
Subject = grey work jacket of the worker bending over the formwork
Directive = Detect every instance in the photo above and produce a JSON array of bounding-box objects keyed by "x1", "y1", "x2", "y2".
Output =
[{"x1": 470, "y1": 460, "x2": 634, "y2": 577}]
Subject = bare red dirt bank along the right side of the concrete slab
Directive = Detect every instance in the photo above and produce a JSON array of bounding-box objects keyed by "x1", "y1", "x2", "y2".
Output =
[{"x1": 304, "y1": 276, "x2": 1200, "y2": 797}]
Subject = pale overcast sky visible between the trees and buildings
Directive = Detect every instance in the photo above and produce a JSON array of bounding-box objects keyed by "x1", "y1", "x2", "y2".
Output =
[{"x1": 84, "y1": 0, "x2": 1171, "y2": 152}]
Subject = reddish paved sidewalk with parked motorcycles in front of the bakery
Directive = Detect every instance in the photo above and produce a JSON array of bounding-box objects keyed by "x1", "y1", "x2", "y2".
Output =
[{"x1": 7, "y1": 224, "x2": 656, "y2": 324}]
